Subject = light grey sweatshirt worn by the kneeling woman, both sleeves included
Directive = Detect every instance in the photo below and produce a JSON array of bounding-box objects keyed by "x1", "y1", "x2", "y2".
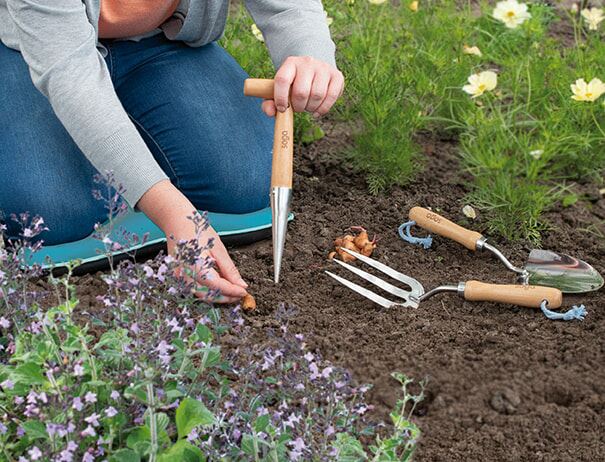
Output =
[{"x1": 0, "y1": 0, "x2": 335, "y2": 208}]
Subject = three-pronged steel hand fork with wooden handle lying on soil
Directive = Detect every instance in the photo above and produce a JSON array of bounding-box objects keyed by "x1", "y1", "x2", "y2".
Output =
[{"x1": 326, "y1": 247, "x2": 563, "y2": 308}]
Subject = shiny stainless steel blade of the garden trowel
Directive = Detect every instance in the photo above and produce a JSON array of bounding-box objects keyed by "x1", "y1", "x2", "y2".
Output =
[{"x1": 525, "y1": 249, "x2": 603, "y2": 293}]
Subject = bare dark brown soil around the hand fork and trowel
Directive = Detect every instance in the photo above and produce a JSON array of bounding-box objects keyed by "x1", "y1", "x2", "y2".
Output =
[{"x1": 71, "y1": 123, "x2": 605, "y2": 461}]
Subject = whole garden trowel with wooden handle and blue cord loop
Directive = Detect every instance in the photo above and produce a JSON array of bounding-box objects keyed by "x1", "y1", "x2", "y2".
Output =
[{"x1": 400, "y1": 207, "x2": 603, "y2": 293}]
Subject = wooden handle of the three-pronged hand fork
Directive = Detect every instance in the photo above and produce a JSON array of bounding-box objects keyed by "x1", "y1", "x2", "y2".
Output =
[{"x1": 464, "y1": 281, "x2": 563, "y2": 308}]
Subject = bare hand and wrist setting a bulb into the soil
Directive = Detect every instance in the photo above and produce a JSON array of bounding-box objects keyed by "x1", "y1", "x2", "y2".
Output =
[{"x1": 137, "y1": 180, "x2": 248, "y2": 303}]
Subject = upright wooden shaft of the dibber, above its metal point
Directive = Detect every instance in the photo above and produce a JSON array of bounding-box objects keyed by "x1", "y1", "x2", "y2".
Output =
[{"x1": 271, "y1": 105, "x2": 294, "y2": 188}]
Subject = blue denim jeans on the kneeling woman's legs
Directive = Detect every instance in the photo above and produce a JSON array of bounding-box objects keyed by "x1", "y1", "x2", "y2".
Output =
[{"x1": 0, "y1": 34, "x2": 273, "y2": 245}]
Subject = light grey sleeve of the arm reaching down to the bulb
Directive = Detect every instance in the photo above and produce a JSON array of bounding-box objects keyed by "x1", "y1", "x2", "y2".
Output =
[{"x1": 7, "y1": 0, "x2": 168, "y2": 208}]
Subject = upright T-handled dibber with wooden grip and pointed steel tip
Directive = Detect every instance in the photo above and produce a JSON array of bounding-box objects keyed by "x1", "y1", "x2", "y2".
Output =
[{"x1": 244, "y1": 79, "x2": 294, "y2": 284}]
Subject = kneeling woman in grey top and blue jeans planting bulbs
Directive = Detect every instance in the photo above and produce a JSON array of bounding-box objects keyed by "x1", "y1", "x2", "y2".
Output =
[{"x1": 0, "y1": 0, "x2": 343, "y2": 302}]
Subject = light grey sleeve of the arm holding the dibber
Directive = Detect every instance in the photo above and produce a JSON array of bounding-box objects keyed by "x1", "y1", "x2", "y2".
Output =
[{"x1": 246, "y1": 0, "x2": 336, "y2": 68}]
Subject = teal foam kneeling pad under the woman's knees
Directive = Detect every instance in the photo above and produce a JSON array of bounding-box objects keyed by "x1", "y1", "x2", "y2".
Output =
[{"x1": 29, "y1": 207, "x2": 294, "y2": 268}]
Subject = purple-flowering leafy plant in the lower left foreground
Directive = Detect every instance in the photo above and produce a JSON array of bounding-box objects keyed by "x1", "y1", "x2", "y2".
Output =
[{"x1": 0, "y1": 175, "x2": 422, "y2": 462}]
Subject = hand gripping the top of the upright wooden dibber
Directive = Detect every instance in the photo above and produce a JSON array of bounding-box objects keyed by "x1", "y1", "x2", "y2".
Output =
[{"x1": 263, "y1": 56, "x2": 344, "y2": 117}]
